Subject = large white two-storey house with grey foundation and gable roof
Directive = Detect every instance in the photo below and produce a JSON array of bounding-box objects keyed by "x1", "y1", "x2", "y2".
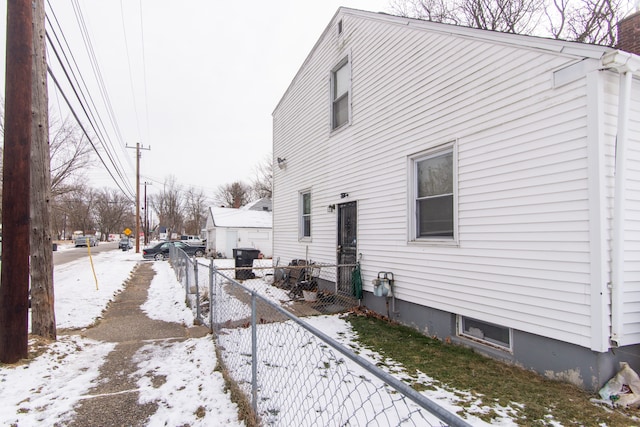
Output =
[{"x1": 273, "y1": 8, "x2": 640, "y2": 389}]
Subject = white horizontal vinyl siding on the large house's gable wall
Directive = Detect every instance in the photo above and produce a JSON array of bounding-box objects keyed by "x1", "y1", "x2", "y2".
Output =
[{"x1": 273, "y1": 11, "x2": 640, "y2": 348}]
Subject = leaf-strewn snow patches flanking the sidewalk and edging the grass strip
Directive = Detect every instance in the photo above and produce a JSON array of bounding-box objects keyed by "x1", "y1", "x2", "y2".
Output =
[{"x1": 0, "y1": 247, "x2": 516, "y2": 426}]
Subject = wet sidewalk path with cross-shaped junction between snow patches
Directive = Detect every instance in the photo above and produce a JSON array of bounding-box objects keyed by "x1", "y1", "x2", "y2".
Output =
[{"x1": 69, "y1": 262, "x2": 209, "y2": 427}]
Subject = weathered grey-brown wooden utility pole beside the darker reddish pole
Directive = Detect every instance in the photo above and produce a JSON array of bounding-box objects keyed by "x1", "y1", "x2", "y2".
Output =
[{"x1": 30, "y1": 0, "x2": 56, "y2": 340}]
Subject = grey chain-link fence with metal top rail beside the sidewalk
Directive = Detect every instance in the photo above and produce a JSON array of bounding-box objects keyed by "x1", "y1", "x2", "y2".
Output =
[{"x1": 170, "y1": 250, "x2": 469, "y2": 426}]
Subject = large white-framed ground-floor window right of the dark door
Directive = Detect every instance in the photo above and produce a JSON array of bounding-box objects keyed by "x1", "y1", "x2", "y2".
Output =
[{"x1": 410, "y1": 142, "x2": 457, "y2": 242}]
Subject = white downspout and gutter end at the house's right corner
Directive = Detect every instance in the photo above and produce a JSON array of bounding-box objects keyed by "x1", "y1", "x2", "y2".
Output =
[{"x1": 602, "y1": 50, "x2": 640, "y2": 348}]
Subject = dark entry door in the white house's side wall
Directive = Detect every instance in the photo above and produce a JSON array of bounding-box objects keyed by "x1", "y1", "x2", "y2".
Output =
[{"x1": 337, "y1": 202, "x2": 358, "y2": 294}]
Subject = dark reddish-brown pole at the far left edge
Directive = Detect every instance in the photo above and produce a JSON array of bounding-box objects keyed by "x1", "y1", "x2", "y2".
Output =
[{"x1": 0, "y1": 0, "x2": 33, "y2": 363}]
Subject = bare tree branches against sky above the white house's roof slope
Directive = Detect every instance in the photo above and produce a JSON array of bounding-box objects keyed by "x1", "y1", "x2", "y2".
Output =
[{"x1": 390, "y1": 0, "x2": 624, "y2": 46}]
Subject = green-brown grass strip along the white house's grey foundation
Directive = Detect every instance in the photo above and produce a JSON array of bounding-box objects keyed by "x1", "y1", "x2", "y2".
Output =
[{"x1": 346, "y1": 314, "x2": 639, "y2": 427}]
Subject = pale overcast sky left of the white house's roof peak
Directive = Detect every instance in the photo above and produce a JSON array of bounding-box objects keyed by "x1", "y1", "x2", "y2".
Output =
[{"x1": 0, "y1": 0, "x2": 389, "y2": 201}]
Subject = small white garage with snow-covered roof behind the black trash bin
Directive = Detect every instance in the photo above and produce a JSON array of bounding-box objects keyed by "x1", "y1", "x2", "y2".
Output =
[{"x1": 206, "y1": 207, "x2": 273, "y2": 258}]
